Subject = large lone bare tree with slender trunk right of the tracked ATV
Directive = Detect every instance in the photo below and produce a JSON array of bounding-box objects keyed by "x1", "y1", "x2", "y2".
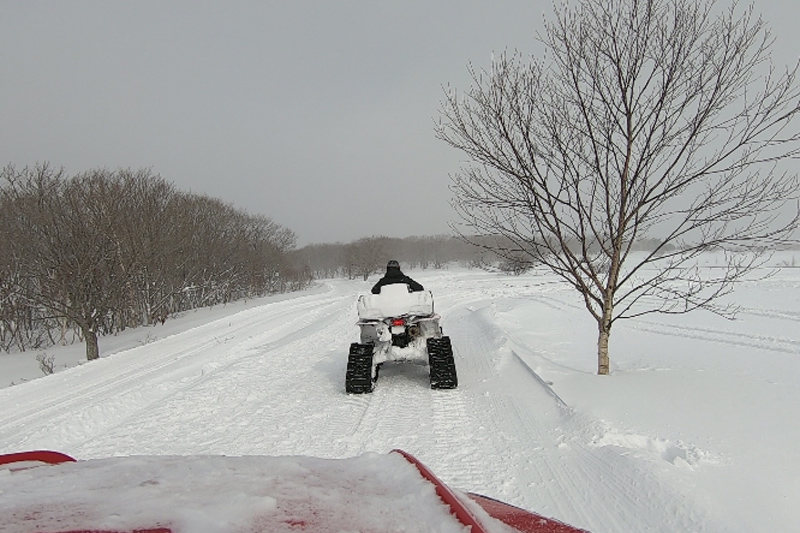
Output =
[{"x1": 437, "y1": 0, "x2": 800, "y2": 374}]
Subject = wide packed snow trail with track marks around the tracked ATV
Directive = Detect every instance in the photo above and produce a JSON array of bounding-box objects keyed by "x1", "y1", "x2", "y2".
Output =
[{"x1": 0, "y1": 272, "x2": 713, "y2": 533}]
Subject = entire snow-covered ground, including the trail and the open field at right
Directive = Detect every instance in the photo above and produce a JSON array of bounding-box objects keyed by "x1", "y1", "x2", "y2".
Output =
[{"x1": 0, "y1": 252, "x2": 800, "y2": 533}]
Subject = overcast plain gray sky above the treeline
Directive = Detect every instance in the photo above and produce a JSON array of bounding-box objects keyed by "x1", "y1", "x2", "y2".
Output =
[{"x1": 0, "y1": 0, "x2": 800, "y2": 245}]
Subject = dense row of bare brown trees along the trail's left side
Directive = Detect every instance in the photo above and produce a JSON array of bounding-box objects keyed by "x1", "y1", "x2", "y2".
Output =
[{"x1": 0, "y1": 165, "x2": 304, "y2": 360}]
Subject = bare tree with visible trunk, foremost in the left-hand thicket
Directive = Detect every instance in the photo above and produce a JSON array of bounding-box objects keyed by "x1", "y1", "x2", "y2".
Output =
[{"x1": 3, "y1": 165, "x2": 121, "y2": 360}]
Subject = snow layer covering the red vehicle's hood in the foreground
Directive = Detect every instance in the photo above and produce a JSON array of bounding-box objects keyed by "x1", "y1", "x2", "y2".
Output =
[{"x1": 0, "y1": 453, "x2": 500, "y2": 533}]
